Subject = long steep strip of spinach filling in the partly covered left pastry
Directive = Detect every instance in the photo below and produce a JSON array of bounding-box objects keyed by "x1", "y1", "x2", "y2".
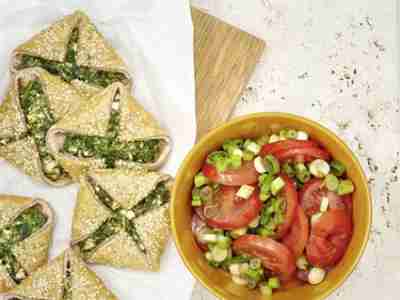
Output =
[{"x1": 19, "y1": 80, "x2": 68, "y2": 181}]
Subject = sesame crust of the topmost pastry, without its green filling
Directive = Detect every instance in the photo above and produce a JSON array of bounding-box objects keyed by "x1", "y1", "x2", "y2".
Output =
[{"x1": 11, "y1": 10, "x2": 132, "y2": 96}]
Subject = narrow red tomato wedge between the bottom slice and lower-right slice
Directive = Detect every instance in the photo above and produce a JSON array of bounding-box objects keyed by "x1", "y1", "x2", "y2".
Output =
[{"x1": 282, "y1": 206, "x2": 310, "y2": 258}]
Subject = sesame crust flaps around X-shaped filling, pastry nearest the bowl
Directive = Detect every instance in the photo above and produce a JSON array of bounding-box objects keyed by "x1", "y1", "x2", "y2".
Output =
[{"x1": 72, "y1": 168, "x2": 172, "y2": 271}]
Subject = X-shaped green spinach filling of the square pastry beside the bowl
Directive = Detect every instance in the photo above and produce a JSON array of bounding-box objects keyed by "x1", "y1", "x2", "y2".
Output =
[{"x1": 78, "y1": 177, "x2": 170, "y2": 258}]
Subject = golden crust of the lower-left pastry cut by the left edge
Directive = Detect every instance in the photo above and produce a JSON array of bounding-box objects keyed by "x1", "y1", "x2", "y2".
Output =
[{"x1": 0, "y1": 195, "x2": 54, "y2": 293}]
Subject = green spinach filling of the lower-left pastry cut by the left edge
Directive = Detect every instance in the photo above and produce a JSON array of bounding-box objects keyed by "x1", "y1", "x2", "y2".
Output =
[{"x1": 0, "y1": 206, "x2": 47, "y2": 284}]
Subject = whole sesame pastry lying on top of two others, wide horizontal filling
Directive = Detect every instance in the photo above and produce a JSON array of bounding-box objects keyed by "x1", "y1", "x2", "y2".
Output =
[{"x1": 47, "y1": 83, "x2": 171, "y2": 181}]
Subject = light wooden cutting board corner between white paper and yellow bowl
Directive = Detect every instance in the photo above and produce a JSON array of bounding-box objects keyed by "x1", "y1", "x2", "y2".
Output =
[{"x1": 192, "y1": 8, "x2": 265, "y2": 138}]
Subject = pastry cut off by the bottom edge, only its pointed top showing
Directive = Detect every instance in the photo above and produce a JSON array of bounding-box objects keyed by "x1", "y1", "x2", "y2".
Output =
[{"x1": 4, "y1": 249, "x2": 117, "y2": 300}]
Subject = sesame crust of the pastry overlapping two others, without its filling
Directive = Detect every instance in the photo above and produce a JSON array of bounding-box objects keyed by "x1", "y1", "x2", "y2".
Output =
[{"x1": 47, "y1": 83, "x2": 171, "y2": 181}]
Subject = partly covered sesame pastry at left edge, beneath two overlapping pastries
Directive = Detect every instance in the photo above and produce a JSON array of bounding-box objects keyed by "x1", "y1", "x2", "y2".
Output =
[{"x1": 0, "y1": 68, "x2": 83, "y2": 186}]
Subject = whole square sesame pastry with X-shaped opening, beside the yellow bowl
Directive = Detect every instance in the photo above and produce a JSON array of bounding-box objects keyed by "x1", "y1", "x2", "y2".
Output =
[{"x1": 72, "y1": 167, "x2": 173, "y2": 271}]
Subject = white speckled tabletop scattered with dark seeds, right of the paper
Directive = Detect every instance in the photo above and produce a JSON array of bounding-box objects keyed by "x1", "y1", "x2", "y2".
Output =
[{"x1": 192, "y1": 0, "x2": 400, "y2": 300}]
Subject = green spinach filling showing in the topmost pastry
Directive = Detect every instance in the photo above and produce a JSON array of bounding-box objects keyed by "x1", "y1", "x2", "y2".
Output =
[{"x1": 17, "y1": 27, "x2": 128, "y2": 88}]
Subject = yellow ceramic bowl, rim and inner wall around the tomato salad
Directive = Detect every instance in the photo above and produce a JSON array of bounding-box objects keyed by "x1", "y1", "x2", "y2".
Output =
[{"x1": 171, "y1": 113, "x2": 371, "y2": 300}]
